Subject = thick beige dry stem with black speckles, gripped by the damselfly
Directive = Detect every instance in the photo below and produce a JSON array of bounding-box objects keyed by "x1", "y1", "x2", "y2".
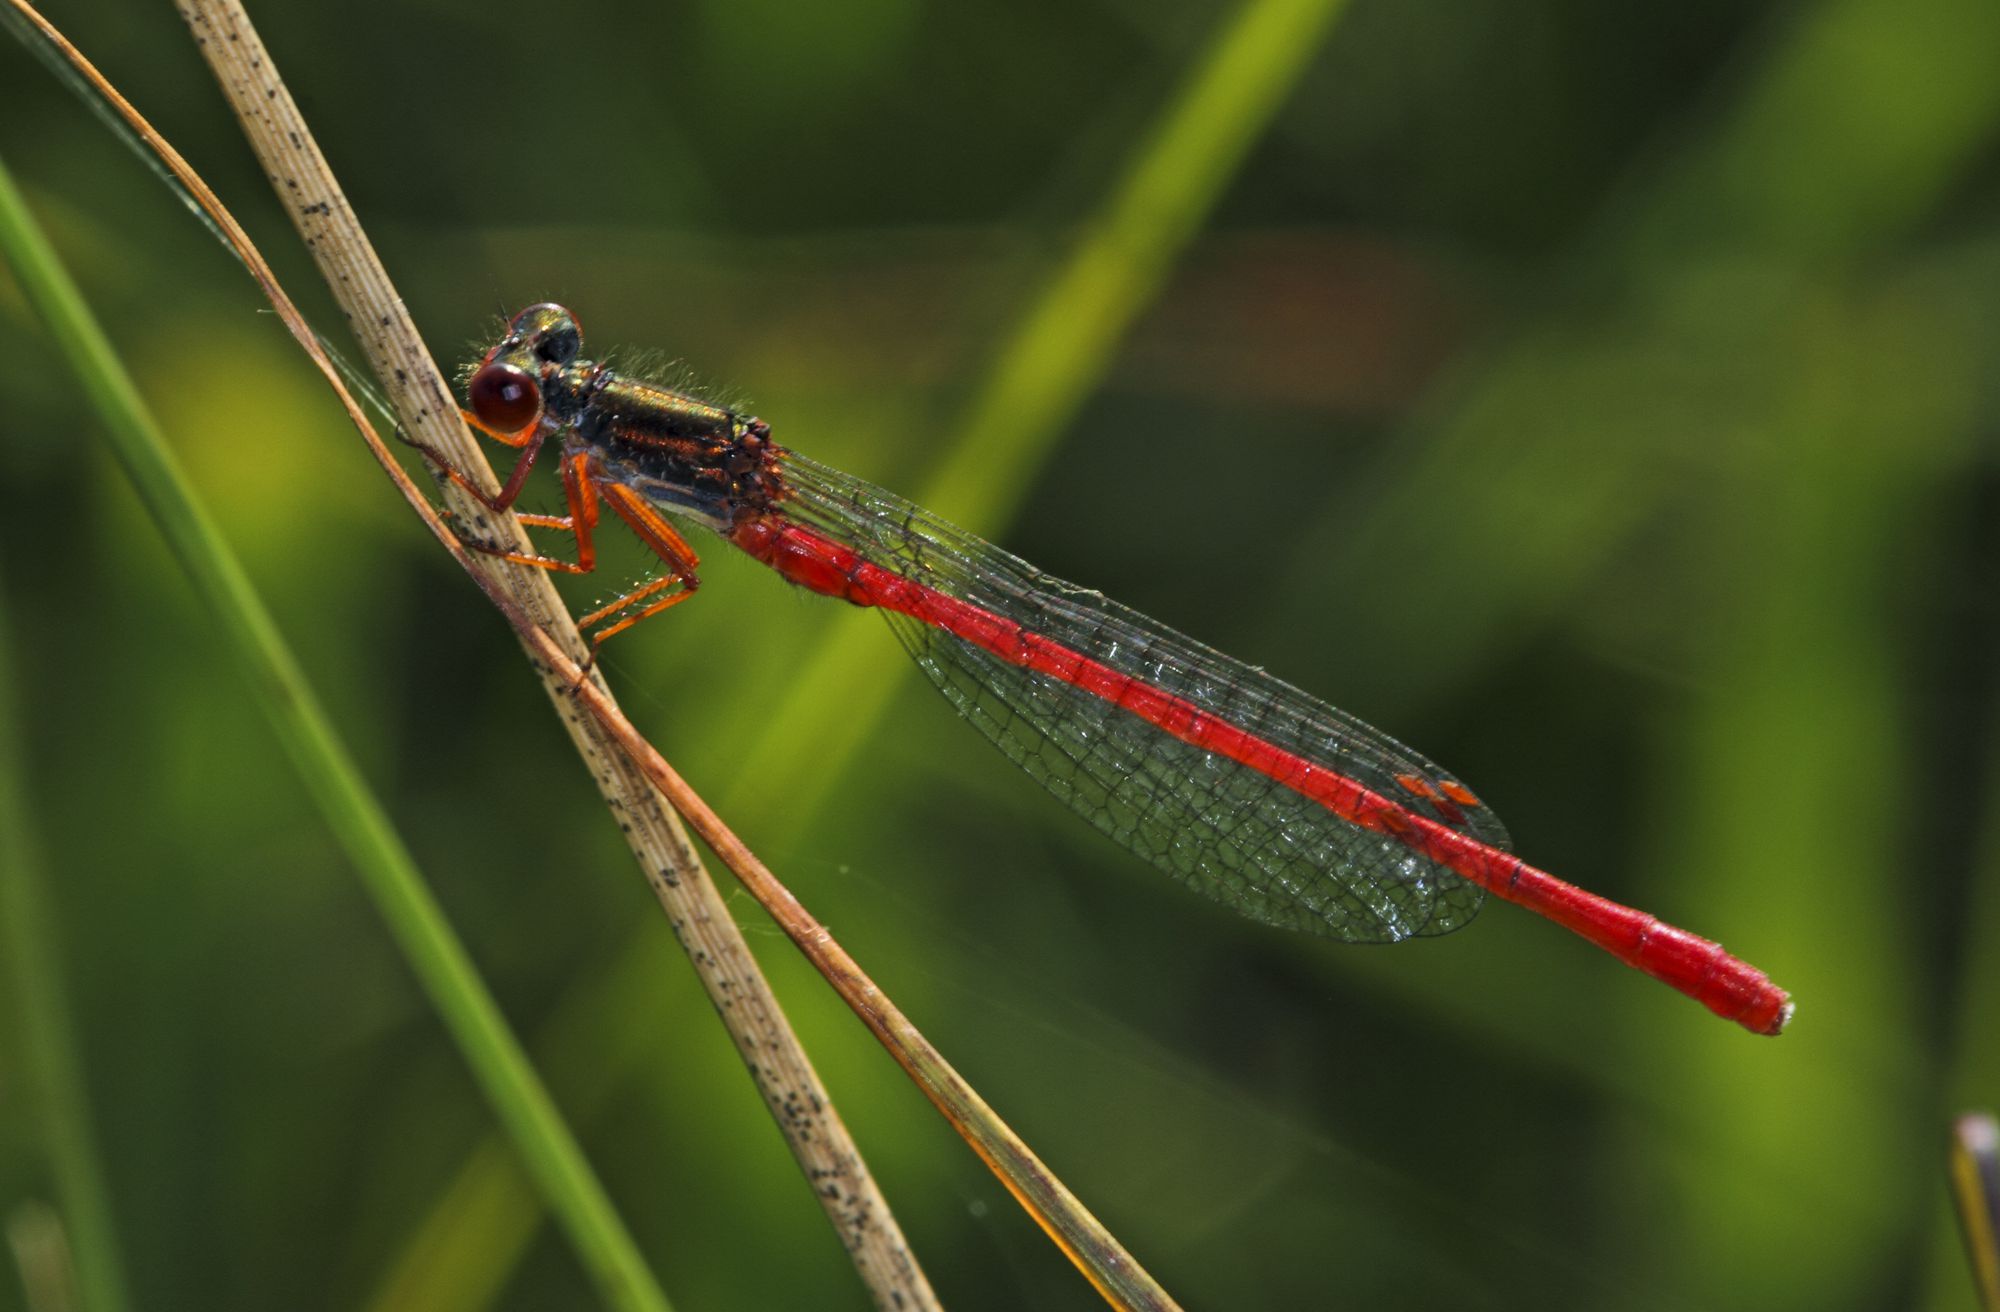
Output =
[{"x1": 178, "y1": 0, "x2": 936, "y2": 1308}]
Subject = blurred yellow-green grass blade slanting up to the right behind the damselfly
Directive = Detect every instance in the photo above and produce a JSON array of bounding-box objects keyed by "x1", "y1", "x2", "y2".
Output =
[{"x1": 378, "y1": 0, "x2": 1344, "y2": 1306}]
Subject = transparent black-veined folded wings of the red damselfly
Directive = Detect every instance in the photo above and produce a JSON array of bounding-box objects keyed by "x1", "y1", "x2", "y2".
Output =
[{"x1": 784, "y1": 452, "x2": 1508, "y2": 942}]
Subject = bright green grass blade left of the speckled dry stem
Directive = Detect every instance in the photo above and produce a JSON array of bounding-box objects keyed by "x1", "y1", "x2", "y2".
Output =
[{"x1": 0, "y1": 149, "x2": 668, "y2": 1310}]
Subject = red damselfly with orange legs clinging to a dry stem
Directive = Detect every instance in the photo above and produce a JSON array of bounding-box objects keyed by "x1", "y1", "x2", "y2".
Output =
[{"x1": 426, "y1": 304, "x2": 1792, "y2": 1034}]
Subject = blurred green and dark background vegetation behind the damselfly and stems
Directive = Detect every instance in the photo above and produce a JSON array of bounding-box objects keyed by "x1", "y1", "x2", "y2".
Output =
[{"x1": 0, "y1": 0, "x2": 2000, "y2": 1310}]
